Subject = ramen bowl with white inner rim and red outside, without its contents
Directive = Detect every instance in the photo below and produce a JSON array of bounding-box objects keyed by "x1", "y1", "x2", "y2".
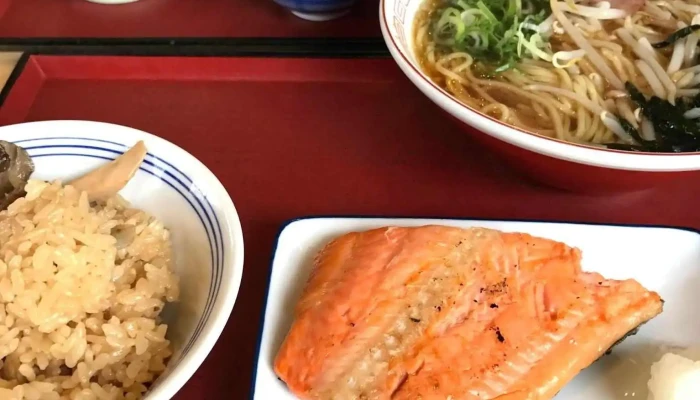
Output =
[{"x1": 379, "y1": 0, "x2": 700, "y2": 193}]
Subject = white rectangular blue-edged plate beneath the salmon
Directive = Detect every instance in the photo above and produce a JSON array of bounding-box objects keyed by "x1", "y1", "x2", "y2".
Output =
[{"x1": 251, "y1": 217, "x2": 700, "y2": 400}]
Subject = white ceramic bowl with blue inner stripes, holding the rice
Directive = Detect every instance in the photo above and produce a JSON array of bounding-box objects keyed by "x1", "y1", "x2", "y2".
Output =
[{"x1": 0, "y1": 121, "x2": 243, "y2": 400}]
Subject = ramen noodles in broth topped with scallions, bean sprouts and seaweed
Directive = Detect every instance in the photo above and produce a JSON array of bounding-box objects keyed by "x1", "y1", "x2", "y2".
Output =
[{"x1": 414, "y1": 0, "x2": 700, "y2": 152}]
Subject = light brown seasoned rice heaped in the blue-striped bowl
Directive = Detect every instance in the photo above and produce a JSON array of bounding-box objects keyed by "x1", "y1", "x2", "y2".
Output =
[{"x1": 0, "y1": 180, "x2": 178, "y2": 400}]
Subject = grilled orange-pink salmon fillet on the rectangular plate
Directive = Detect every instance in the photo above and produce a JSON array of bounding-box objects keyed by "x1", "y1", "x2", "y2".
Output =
[{"x1": 274, "y1": 226, "x2": 663, "y2": 400}]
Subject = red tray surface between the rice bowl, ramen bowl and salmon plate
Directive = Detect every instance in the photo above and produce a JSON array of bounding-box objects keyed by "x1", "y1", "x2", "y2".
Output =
[{"x1": 0, "y1": 56, "x2": 700, "y2": 399}]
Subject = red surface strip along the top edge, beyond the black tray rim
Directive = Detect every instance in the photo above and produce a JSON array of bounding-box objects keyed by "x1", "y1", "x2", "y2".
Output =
[{"x1": 0, "y1": 0, "x2": 381, "y2": 38}]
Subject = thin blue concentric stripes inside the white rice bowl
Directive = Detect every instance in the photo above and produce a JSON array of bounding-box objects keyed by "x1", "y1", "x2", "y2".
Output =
[{"x1": 15, "y1": 137, "x2": 225, "y2": 368}]
